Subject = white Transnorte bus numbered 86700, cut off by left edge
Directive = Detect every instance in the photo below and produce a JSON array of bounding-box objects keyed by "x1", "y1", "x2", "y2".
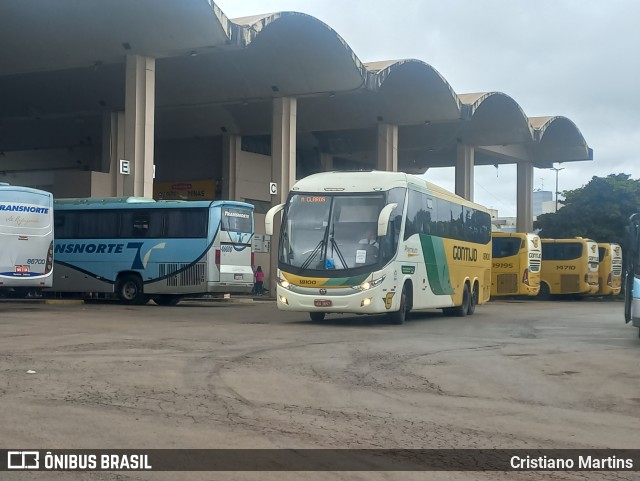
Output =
[{"x1": 0, "y1": 183, "x2": 53, "y2": 297}]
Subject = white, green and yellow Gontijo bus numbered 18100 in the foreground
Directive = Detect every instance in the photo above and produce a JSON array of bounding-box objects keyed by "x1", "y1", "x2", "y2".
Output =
[{"x1": 265, "y1": 171, "x2": 491, "y2": 324}]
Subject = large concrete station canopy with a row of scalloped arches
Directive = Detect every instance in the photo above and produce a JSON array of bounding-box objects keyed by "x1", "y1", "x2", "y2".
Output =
[{"x1": 0, "y1": 0, "x2": 593, "y2": 178}]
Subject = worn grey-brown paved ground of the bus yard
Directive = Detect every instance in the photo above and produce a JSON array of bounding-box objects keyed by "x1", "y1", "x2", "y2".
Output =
[{"x1": 0, "y1": 300, "x2": 640, "y2": 480}]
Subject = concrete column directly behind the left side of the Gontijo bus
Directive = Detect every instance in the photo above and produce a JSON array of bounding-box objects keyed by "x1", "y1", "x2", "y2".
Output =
[{"x1": 268, "y1": 97, "x2": 298, "y2": 294}]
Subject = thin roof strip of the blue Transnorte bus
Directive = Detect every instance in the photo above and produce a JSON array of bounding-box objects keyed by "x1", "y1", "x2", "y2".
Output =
[{"x1": 53, "y1": 197, "x2": 253, "y2": 210}]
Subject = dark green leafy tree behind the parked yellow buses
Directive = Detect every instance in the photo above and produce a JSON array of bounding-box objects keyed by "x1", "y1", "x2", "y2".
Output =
[{"x1": 534, "y1": 174, "x2": 640, "y2": 245}]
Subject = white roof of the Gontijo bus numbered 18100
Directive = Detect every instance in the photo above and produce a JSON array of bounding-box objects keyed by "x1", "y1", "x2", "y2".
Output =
[{"x1": 291, "y1": 170, "x2": 486, "y2": 210}]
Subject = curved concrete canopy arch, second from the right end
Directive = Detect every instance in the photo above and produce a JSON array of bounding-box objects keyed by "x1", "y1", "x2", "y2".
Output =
[{"x1": 460, "y1": 92, "x2": 534, "y2": 145}]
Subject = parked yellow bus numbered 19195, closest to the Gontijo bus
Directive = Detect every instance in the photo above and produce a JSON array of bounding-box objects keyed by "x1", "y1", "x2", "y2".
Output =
[{"x1": 491, "y1": 232, "x2": 542, "y2": 297}]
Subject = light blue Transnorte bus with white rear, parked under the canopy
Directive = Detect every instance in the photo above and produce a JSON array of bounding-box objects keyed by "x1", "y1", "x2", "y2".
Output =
[{"x1": 51, "y1": 197, "x2": 254, "y2": 305}]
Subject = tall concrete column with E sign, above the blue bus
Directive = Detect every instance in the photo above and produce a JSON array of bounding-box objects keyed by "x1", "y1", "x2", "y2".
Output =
[{"x1": 123, "y1": 55, "x2": 156, "y2": 197}]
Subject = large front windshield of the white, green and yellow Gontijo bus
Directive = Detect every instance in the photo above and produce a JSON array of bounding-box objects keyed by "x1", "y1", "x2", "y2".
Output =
[{"x1": 279, "y1": 193, "x2": 392, "y2": 271}]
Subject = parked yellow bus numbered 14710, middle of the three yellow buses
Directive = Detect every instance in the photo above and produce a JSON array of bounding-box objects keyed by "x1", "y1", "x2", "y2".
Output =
[{"x1": 539, "y1": 237, "x2": 598, "y2": 298}]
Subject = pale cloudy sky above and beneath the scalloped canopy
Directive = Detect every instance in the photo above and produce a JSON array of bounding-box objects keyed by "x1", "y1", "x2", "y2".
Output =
[{"x1": 215, "y1": 0, "x2": 640, "y2": 216}]
